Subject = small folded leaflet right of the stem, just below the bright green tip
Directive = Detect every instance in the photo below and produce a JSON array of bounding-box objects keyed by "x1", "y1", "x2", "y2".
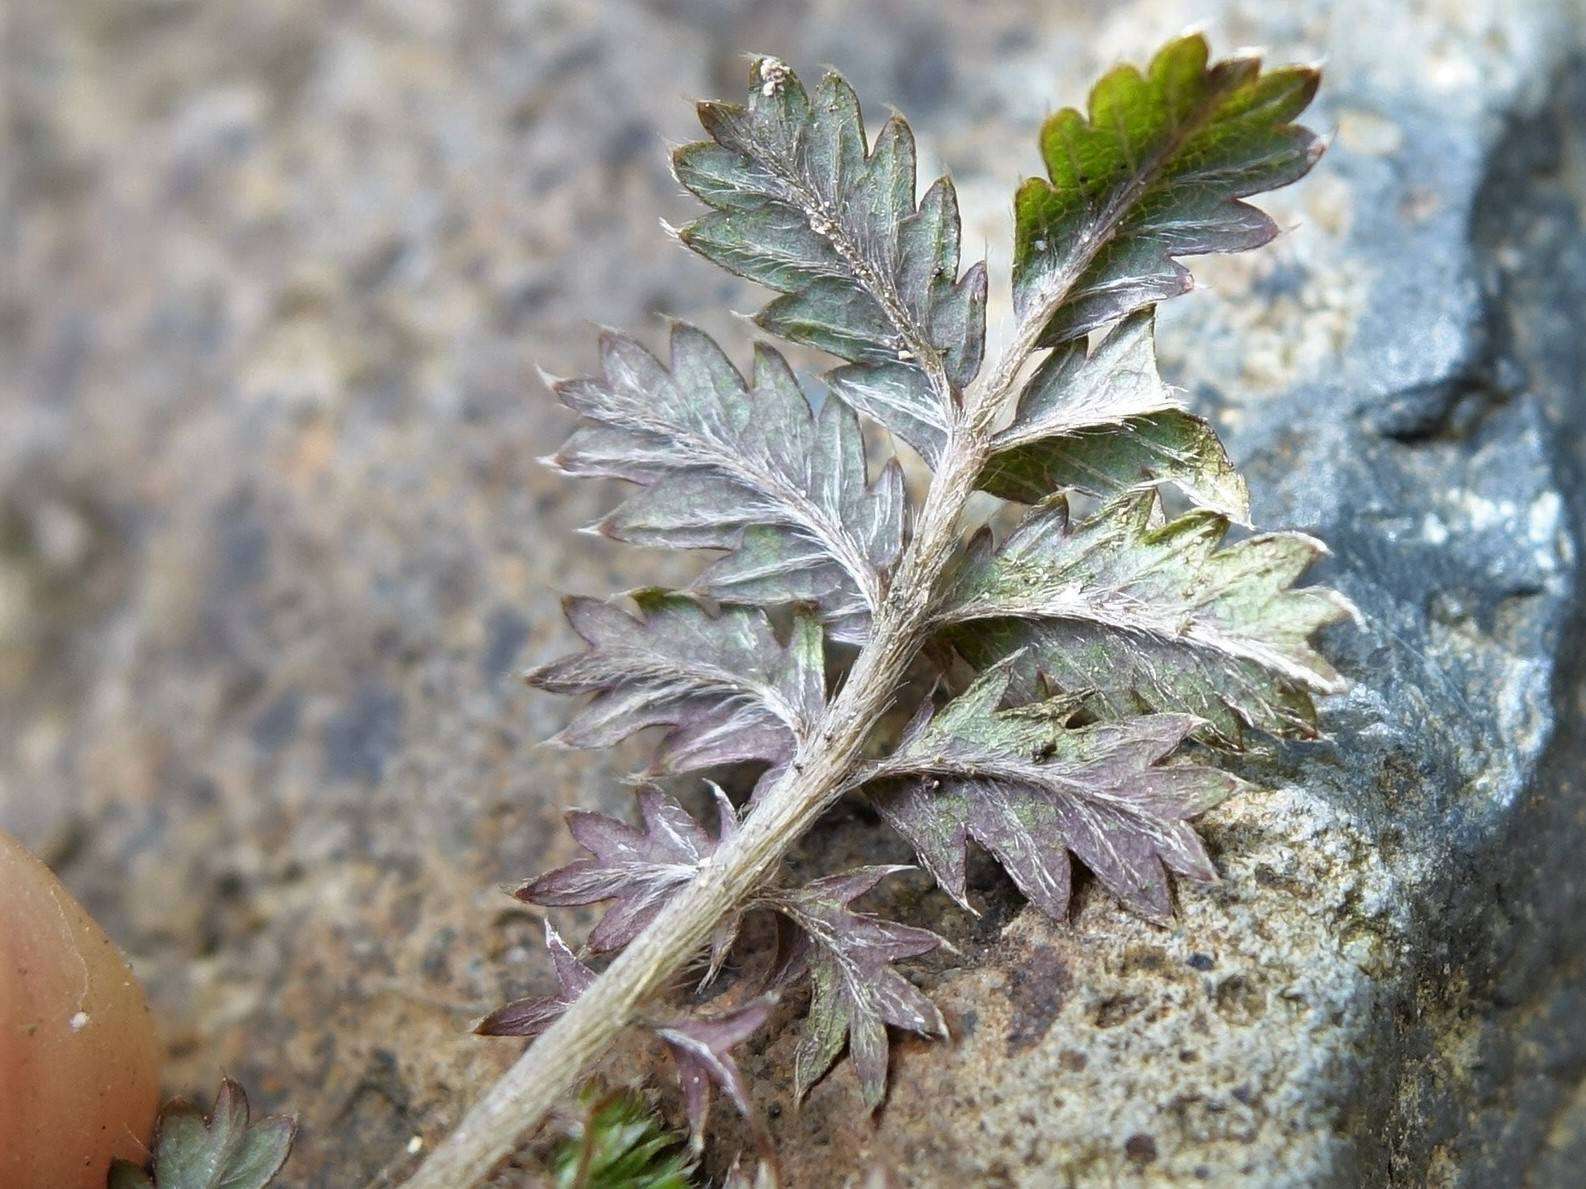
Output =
[{"x1": 980, "y1": 309, "x2": 1250, "y2": 523}]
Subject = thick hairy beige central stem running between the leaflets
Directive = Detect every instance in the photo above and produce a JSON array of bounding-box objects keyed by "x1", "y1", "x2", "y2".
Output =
[{"x1": 408, "y1": 415, "x2": 996, "y2": 1189}]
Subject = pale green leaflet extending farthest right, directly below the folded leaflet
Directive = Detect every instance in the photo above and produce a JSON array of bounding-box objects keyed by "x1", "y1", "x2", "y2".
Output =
[{"x1": 940, "y1": 493, "x2": 1353, "y2": 744}]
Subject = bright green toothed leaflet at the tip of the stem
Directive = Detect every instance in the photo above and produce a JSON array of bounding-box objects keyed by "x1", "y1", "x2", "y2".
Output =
[{"x1": 1013, "y1": 35, "x2": 1323, "y2": 346}]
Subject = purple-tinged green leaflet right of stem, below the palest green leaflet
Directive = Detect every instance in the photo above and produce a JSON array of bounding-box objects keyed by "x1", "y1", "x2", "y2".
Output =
[{"x1": 872, "y1": 663, "x2": 1240, "y2": 919}]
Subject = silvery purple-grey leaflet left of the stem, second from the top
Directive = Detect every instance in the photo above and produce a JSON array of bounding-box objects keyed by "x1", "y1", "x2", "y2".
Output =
[{"x1": 549, "y1": 323, "x2": 906, "y2": 640}]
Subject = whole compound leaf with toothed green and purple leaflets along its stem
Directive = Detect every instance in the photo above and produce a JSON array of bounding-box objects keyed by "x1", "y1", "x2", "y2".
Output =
[{"x1": 479, "y1": 36, "x2": 1353, "y2": 1147}]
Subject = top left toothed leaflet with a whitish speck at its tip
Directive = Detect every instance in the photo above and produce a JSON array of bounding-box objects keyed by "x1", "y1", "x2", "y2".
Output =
[{"x1": 672, "y1": 57, "x2": 986, "y2": 457}]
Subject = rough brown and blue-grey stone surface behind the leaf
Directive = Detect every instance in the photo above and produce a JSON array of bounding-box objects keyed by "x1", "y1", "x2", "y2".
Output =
[{"x1": 0, "y1": 0, "x2": 1586, "y2": 1186}]
